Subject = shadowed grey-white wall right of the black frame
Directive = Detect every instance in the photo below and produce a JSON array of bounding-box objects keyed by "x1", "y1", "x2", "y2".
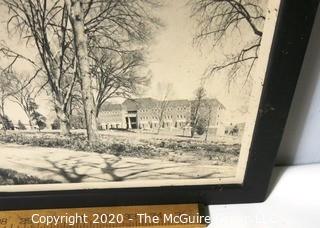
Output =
[{"x1": 277, "y1": 6, "x2": 320, "y2": 165}]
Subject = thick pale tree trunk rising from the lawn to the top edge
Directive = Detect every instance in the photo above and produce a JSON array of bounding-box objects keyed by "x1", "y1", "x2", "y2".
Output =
[{"x1": 65, "y1": 0, "x2": 97, "y2": 142}]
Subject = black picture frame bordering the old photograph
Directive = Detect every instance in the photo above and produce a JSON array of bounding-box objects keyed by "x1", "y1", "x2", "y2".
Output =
[{"x1": 0, "y1": 0, "x2": 319, "y2": 210}]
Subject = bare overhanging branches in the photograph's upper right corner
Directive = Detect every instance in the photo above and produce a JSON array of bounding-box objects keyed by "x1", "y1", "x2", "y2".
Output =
[{"x1": 189, "y1": 0, "x2": 267, "y2": 81}]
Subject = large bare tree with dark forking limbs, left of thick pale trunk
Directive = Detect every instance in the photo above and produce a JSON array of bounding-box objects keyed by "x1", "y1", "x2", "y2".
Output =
[{"x1": 1, "y1": 0, "x2": 76, "y2": 135}]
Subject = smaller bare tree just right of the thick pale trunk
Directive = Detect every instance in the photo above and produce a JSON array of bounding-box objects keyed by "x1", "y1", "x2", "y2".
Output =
[{"x1": 91, "y1": 51, "x2": 150, "y2": 117}]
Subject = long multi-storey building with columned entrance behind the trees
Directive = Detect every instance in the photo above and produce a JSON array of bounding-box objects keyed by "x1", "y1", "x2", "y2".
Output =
[{"x1": 99, "y1": 98, "x2": 225, "y2": 134}]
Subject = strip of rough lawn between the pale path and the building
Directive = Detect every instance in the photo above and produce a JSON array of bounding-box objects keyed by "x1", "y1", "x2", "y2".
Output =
[{"x1": 0, "y1": 131, "x2": 240, "y2": 165}]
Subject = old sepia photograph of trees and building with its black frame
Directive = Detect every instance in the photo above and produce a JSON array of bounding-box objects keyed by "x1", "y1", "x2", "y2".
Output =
[{"x1": 0, "y1": 0, "x2": 318, "y2": 210}]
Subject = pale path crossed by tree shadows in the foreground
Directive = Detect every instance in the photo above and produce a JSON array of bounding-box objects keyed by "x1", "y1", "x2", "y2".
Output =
[{"x1": 0, "y1": 143, "x2": 235, "y2": 183}]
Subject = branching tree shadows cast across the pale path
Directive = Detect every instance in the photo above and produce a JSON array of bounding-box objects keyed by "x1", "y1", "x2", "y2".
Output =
[{"x1": 31, "y1": 155, "x2": 225, "y2": 183}]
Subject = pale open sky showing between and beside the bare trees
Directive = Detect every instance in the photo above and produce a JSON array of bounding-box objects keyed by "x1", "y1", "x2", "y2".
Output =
[{"x1": 0, "y1": 0, "x2": 264, "y2": 122}]
